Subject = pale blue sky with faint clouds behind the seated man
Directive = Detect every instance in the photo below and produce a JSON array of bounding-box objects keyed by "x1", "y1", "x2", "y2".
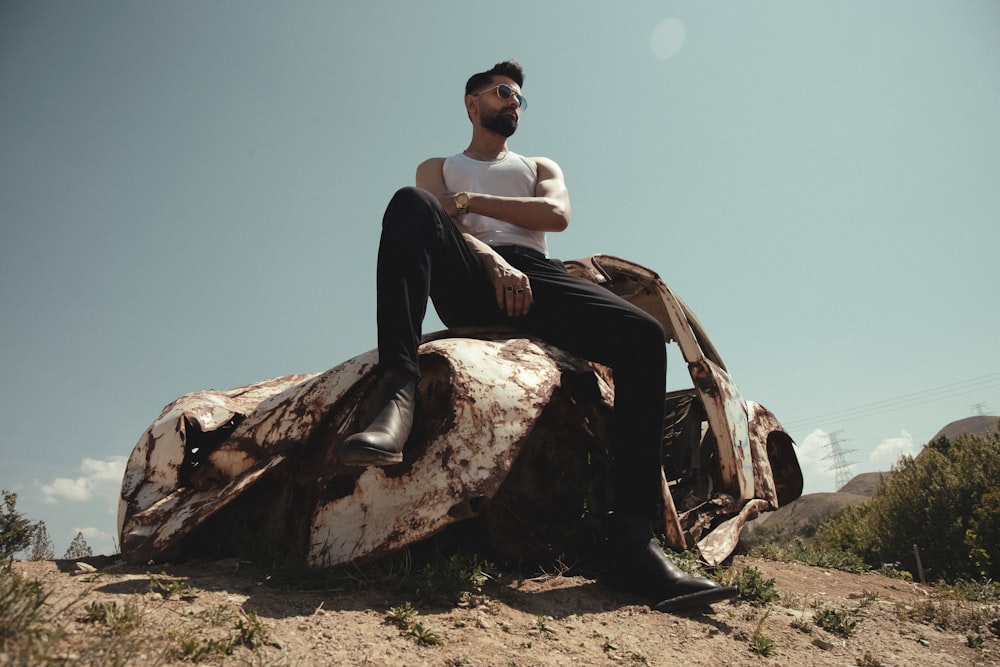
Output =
[{"x1": 0, "y1": 0, "x2": 1000, "y2": 555}]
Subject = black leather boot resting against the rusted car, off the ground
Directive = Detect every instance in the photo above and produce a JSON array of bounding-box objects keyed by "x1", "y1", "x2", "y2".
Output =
[{"x1": 341, "y1": 373, "x2": 417, "y2": 466}]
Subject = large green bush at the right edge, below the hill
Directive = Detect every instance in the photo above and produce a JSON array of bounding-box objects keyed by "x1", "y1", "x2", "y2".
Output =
[{"x1": 815, "y1": 433, "x2": 1000, "y2": 580}]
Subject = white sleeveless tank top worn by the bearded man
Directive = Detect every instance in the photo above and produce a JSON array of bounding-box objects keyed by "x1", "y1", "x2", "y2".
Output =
[{"x1": 443, "y1": 151, "x2": 549, "y2": 257}]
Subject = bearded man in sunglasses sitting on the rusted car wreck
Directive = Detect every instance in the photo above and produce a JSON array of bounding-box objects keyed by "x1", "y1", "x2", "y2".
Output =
[{"x1": 342, "y1": 62, "x2": 735, "y2": 610}]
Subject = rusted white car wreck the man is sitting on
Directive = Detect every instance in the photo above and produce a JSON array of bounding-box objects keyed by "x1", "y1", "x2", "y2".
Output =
[{"x1": 118, "y1": 255, "x2": 802, "y2": 566}]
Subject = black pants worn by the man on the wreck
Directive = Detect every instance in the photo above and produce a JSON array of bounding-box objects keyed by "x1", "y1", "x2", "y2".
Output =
[{"x1": 377, "y1": 187, "x2": 667, "y2": 517}]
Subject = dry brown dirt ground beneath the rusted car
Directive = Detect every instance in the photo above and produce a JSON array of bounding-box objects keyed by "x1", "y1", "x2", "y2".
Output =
[{"x1": 7, "y1": 557, "x2": 1000, "y2": 667}]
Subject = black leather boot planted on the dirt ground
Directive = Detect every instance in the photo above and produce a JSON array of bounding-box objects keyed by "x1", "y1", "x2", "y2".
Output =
[{"x1": 605, "y1": 516, "x2": 739, "y2": 612}]
